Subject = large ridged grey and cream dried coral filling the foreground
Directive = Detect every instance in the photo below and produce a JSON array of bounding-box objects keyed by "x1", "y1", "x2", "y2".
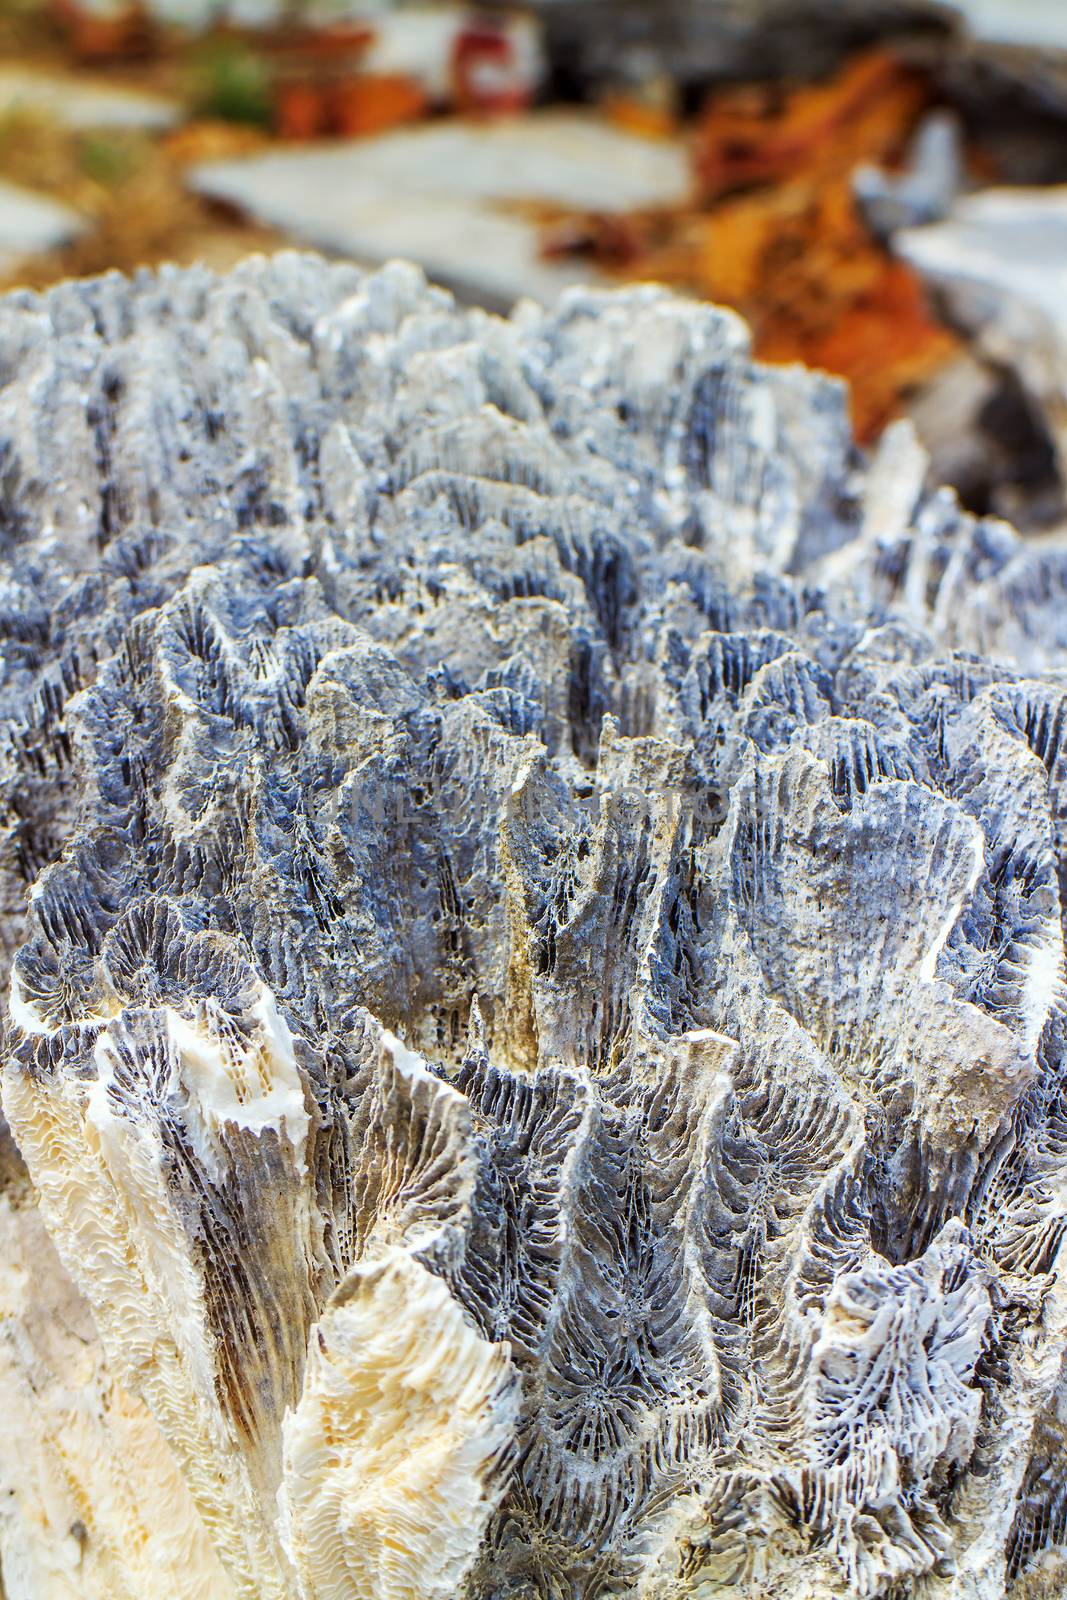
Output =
[{"x1": 0, "y1": 256, "x2": 1067, "y2": 1600}]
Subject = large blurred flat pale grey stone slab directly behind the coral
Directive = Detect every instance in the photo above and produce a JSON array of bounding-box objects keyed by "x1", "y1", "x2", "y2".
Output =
[{"x1": 190, "y1": 112, "x2": 689, "y2": 306}]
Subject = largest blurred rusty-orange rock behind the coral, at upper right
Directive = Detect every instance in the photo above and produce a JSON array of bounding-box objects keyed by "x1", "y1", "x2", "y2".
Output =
[{"x1": 545, "y1": 53, "x2": 958, "y2": 442}]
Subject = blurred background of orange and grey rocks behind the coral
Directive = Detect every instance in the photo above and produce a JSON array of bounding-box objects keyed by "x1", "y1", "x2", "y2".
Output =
[{"x1": 0, "y1": 0, "x2": 1067, "y2": 534}]
